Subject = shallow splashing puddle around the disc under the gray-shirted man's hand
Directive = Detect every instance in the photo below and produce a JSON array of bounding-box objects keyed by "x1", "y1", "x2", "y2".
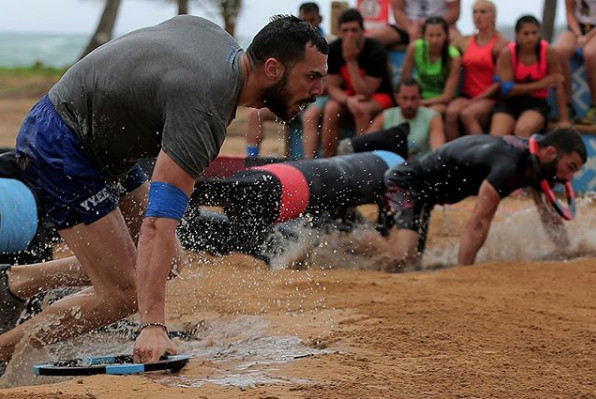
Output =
[{"x1": 4, "y1": 316, "x2": 332, "y2": 389}]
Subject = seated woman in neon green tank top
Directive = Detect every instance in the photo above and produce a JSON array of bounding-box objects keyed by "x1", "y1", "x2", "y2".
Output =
[{"x1": 402, "y1": 17, "x2": 461, "y2": 113}]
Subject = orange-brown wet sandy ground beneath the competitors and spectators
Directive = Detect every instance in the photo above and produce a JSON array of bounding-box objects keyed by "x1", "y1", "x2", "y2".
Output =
[{"x1": 0, "y1": 79, "x2": 596, "y2": 399}]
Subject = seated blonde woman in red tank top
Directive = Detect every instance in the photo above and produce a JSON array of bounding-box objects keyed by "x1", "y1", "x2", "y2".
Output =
[{"x1": 445, "y1": 0, "x2": 507, "y2": 141}]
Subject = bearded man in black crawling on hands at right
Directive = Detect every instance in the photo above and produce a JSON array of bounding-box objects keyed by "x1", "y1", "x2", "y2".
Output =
[{"x1": 385, "y1": 129, "x2": 587, "y2": 272}]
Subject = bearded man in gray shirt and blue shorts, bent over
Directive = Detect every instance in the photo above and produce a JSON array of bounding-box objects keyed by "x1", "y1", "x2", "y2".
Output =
[{"x1": 0, "y1": 16, "x2": 327, "y2": 362}]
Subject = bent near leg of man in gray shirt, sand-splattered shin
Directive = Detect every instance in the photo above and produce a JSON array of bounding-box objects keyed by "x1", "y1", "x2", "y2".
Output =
[{"x1": 0, "y1": 208, "x2": 137, "y2": 361}]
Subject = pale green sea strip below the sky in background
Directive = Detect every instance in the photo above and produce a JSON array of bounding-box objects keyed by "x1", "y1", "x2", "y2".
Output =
[{"x1": 0, "y1": 26, "x2": 562, "y2": 68}]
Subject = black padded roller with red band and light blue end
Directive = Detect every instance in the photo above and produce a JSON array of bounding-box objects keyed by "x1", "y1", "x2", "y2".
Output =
[{"x1": 180, "y1": 151, "x2": 403, "y2": 255}]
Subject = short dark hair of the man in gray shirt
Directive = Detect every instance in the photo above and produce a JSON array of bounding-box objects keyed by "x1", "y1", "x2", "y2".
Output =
[{"x1": 246, "y1": 15, "x2": 329, "y2": 67}]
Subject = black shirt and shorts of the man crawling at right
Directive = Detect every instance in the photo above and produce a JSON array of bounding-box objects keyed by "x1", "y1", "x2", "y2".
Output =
[{"x1": 385, "y1": 136, "x2": 533, "y2": 252}]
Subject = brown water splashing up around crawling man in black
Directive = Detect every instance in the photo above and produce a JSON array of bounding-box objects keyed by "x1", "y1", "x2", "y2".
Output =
[{"x1": 272, "y1": 194, "x2": 596, "y2": 270}]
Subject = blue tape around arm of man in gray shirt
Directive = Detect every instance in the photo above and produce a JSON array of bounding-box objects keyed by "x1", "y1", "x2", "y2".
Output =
[{"x1": 145, "y1": 181, "x2": 189, "y2": 220}]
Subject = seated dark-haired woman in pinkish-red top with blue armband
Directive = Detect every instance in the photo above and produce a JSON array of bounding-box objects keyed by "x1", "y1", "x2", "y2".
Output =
[{"x1": 490, "y1": 15, "x2": 569, "y2": 137}]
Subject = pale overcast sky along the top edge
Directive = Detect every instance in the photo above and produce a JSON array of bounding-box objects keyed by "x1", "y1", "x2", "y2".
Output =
[{"x1": 0, "y1": 0, "x2": 565, "y2": 38}]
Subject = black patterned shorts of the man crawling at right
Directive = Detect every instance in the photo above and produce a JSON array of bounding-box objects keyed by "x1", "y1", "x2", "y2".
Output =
[{"x1": 386, "y1": 184, "x2": 434, "y2": 253}]
